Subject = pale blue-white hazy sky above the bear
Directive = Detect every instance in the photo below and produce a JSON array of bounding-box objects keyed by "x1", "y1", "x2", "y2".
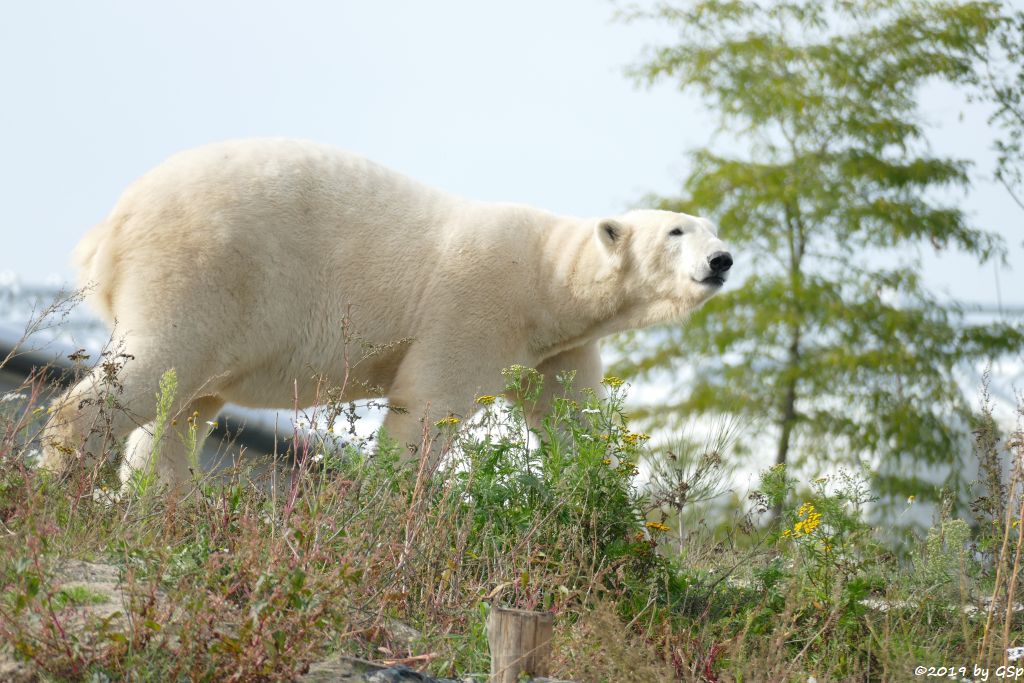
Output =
[{"x1": 0, "y1": 0, "x2": 1024, "y2": 304}]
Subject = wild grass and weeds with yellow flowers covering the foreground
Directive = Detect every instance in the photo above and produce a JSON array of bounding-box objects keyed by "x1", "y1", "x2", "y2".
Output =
[{"x1": 0, "y1": 348, "x2": 1024, "y2": 681}]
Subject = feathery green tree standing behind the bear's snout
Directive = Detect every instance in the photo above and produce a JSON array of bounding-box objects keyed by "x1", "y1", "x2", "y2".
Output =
[{"x1": 616, "y1": 0, "x2": 1024, "y2": 496}]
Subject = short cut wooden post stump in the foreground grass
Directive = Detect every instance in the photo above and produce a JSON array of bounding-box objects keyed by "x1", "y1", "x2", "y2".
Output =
[{"x1": 487, "y1": 607, "x2": 554, "y2": 683}]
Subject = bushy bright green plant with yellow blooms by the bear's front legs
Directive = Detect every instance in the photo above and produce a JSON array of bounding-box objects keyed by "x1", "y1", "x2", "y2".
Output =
[{"x1": 451, "y1": 367, "x2": 664, "y2": 608}]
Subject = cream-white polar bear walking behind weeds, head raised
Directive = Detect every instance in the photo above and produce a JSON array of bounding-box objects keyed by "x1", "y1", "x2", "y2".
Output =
[{"x1": 43, "y1": 139, "x2": 732, "y2": 485}]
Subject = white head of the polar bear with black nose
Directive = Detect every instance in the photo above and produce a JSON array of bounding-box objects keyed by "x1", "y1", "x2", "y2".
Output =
[{"x1": 596, "y1": 210, "x2": 732, "y2": 327}]
